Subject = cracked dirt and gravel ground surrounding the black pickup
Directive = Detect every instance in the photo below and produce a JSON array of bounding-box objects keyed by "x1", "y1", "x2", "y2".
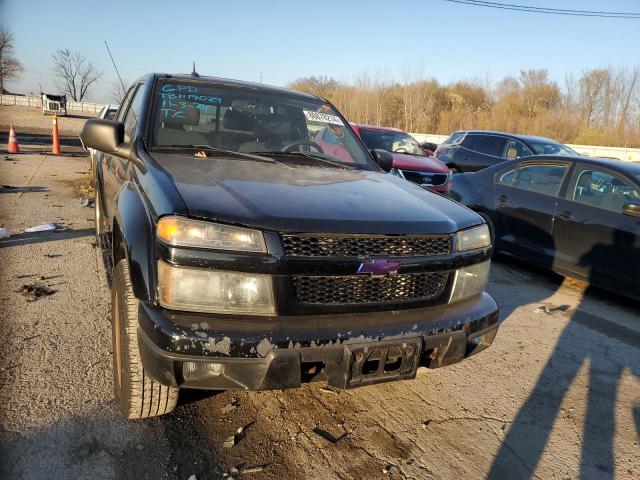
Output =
[{"x1": 0, "y1": 155, "x2": 640, "y2": 480}]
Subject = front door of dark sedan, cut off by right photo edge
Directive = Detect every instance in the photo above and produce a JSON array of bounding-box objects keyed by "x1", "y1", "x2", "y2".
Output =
[{"x1": 553, "y1": 163, "x2": 640, "y2": 295}]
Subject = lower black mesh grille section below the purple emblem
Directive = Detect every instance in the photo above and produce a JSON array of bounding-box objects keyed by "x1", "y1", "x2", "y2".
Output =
[{"x1": 293, "y1": 272, "x2": 449, "y2": 305}]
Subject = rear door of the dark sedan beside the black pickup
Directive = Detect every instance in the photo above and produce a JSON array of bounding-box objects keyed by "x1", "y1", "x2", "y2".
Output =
[{"x1": 493, "y1": 160, "x2": 570, "y2": 268}]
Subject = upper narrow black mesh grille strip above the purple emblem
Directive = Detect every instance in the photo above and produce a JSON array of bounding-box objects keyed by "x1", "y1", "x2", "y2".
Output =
[{"x1": 282, "y1": 235, "x2": 453, "y2": 258}]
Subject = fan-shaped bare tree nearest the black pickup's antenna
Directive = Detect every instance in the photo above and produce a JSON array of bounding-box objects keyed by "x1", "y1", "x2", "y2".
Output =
[{"x1": 52, "y1": 48, "x2": 103, "y2": 102}]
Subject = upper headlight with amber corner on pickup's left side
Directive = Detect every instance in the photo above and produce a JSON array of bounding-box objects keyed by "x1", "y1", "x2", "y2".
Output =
[{"x1": 156, "y1": 217, "x2": 267, "y2": 253}]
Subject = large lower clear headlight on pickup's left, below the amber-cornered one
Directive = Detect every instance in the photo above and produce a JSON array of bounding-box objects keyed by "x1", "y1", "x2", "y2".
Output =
[{"x1": 158, "y1": 260, "x2": 275, "y2": 315}]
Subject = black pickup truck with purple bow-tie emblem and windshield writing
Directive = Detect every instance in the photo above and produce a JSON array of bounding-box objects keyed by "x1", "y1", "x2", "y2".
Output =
[{"x1": 81, "y1": 74, "x2": 498, "y2": 418}]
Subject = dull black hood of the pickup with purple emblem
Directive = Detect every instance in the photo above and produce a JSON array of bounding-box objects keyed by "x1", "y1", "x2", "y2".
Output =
[{"x1": 153, "y1": 153, "x2": 482, "y2": 234}]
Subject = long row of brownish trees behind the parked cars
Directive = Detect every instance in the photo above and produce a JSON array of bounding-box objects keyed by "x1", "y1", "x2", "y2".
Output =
[{"x1": 289, "y1": 66, "x2": 640, "y2": 147}]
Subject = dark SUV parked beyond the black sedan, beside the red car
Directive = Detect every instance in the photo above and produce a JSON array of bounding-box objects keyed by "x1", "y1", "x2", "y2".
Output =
[{"x1": 434, "y1": 130, "x2": 578, "y2": 173}]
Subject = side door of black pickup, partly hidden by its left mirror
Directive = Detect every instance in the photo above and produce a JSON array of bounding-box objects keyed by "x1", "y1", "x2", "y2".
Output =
[{"x1": 102, "y1": 85, "x2": 144, "y2": 218}]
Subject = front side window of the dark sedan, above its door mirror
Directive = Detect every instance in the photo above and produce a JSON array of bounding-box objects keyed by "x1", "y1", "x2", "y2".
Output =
[{"x1": 568, "y1": 167, "x2": 640, "y2": 213}]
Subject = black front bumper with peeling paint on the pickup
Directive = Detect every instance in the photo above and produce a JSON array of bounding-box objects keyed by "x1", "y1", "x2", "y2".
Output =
[{"x1": 138, "y1": 293, "x2": 498, "y2": 390}]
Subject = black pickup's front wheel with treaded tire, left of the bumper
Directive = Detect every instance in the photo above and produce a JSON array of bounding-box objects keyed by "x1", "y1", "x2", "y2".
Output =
[{"x1": 111, "y1": 259, "x2": 178, "y2": 419}]
